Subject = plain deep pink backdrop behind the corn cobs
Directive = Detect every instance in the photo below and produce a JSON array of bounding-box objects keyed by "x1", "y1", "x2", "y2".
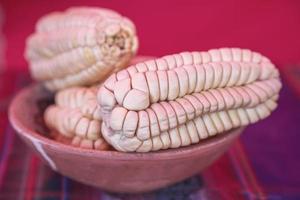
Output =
[{"x1": 0, "y1": 0, "x2": 300, "y2": 69}]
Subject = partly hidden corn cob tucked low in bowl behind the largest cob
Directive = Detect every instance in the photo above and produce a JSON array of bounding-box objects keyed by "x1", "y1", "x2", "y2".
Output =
[{"x1": 44, "y1": 87, "x2": 109, "y2": 150}]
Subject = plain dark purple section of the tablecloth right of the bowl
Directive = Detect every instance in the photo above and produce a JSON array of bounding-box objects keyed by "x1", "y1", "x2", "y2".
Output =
[{"x1": 241, "y1": 84, "x2": 300, "y2": 199}]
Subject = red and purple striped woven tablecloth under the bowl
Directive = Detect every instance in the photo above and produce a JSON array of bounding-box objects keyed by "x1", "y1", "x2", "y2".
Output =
[{"x1": 0, "y1": 69, "x2": 300, "y2": 200}]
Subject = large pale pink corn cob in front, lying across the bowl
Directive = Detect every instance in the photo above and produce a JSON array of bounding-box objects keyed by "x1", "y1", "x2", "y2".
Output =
[{"x1": 98, "y1": 48, "x2": 281, "y2": 152}]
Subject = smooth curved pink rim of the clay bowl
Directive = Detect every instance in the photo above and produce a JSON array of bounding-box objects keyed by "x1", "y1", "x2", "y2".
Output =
[{"x1": 8, "y1": 83, "x2": 244, "y2": 161}]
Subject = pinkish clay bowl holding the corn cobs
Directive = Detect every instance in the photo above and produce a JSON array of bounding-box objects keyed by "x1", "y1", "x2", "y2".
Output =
[{"x1": 9, "y1": 85, "x2": 243, "y2": 193}]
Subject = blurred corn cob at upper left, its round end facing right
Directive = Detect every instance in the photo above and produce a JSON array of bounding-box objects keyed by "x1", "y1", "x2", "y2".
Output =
[{"x1": 25, "y1": 7, "x2": 138, "y2": 91}]
